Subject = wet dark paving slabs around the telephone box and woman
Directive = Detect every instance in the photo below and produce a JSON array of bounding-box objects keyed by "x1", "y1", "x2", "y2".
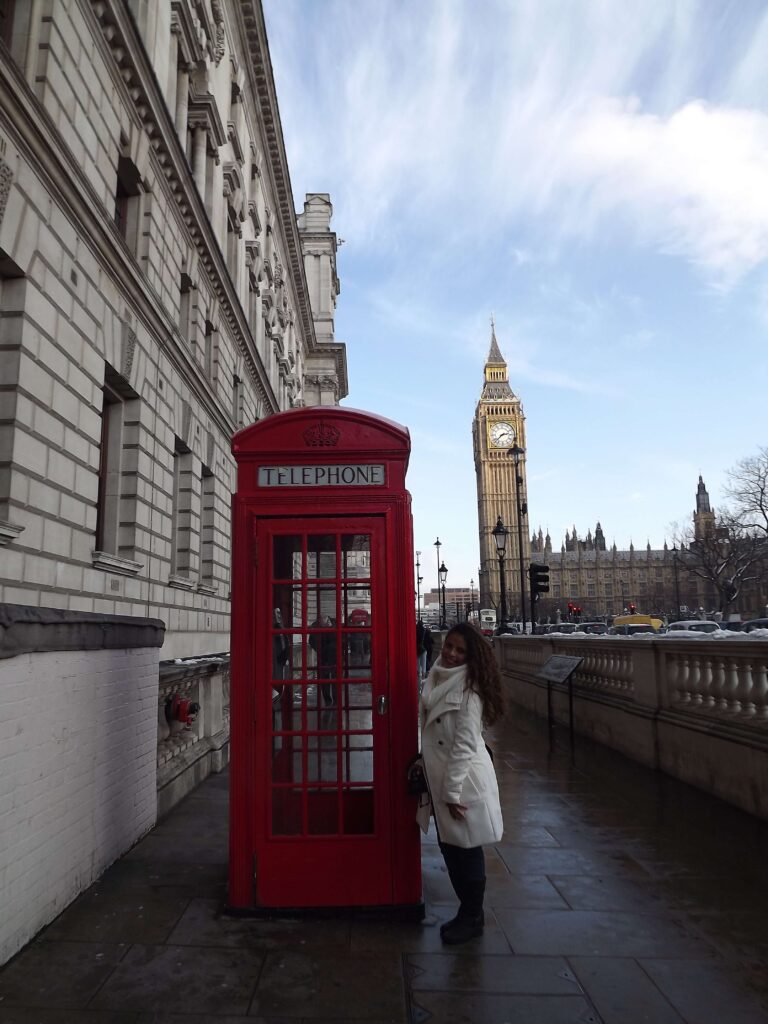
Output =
[{"x1": 0, "y1": 709, "x2": 768, "y2": 1024}]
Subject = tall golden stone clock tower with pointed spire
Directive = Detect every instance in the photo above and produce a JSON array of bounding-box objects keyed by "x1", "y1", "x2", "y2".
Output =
[{"x1": 472, "y1": 321, "x2": 530, "y2": 618}]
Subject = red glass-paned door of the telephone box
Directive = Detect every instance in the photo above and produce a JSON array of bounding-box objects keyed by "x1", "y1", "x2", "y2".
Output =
[{"x1": 253, "y1": 515, "x2": 392, "y2": 906}]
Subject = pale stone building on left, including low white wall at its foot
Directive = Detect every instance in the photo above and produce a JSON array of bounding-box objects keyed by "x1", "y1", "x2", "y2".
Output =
[{"x1": 0, "y1": 0, "x2": 347, "y2": 963}]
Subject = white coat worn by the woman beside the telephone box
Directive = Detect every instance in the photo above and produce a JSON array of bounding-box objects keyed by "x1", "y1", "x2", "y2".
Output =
[{"x1": 416, "y1": 659, "x2": 504, "y2": 849}]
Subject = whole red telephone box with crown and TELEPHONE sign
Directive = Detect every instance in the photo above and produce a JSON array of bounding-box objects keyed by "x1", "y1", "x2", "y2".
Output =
[{"x1": 229, "y1": 407, "x2": 423, "y2": 918}]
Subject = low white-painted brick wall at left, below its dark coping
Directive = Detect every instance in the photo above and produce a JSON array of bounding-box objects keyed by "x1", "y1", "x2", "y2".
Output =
[{"x1": 0, "y1": 647, "x2": 159, "y2": 964}]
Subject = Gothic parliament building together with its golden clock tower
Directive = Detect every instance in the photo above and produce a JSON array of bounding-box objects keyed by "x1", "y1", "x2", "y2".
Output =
[{"x1": 472, "y1": 328, "x2": 733, "y2": 621}]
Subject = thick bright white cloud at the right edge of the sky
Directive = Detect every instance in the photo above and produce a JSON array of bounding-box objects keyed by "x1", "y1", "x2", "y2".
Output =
[{"x1": 561, "y1": 99, "x2": 768, "y2": 289}]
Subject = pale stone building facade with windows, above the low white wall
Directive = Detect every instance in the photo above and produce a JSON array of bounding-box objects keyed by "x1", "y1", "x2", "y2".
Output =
[{"x1": 0, "y1": 0, "x2": 347, "y2": 659}]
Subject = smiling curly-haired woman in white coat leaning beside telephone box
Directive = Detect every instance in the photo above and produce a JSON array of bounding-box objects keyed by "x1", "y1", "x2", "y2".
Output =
[{"x1": 417, "y1": 623, "x2": 504, "y2": 945}]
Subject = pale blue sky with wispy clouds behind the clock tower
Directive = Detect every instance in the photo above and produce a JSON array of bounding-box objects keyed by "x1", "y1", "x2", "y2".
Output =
[{"x1": 264, "y1": 0, "x2": 768, "y2": 589}]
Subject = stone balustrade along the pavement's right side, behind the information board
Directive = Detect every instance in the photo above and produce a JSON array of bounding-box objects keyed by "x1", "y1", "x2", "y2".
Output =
[{"x1": 494, "y1": 635, "x2": 768, "y2": 818}]
